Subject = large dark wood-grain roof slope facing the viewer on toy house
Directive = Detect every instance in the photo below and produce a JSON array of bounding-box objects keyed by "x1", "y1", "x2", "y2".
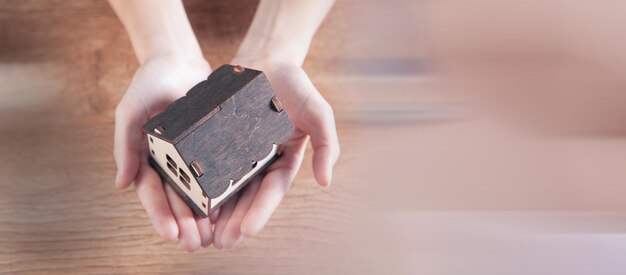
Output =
[{"x1": 175, "y1": 68, "x2": 293, "y2": 198}]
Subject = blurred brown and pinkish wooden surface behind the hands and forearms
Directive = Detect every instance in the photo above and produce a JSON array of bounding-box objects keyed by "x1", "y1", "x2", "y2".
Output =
[{"x1": 0, "y1": 0, "x2": 626, "y2": 274}]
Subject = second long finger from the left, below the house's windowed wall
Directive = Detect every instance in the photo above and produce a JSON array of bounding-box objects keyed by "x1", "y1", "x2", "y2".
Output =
[{"x1": 165, "y1": 184, "x2": 201, "y2": 252}]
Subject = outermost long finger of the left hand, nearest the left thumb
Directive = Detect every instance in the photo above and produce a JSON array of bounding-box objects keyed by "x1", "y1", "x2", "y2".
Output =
[{"x1": 135, "y1": 164, "x2": 178, "y2": 241}]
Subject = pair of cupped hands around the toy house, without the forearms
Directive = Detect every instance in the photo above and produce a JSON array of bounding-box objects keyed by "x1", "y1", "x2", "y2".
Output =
[{"x1": 114, "y1": 55, "x2": 339, "y2": 251}]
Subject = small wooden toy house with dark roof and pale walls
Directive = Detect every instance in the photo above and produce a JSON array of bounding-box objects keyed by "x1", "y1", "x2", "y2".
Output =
[{"x1": 143, "y1": 65, "x2": 293, "y2": 217}]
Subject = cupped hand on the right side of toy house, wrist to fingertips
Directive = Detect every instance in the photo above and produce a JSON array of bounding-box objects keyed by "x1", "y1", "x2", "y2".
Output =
[{"x1": 213, "y1": 60, "x2": 339, "y2": 248}]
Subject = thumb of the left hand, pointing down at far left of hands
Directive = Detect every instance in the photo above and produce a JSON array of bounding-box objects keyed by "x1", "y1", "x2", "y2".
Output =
[{"x1": 113, "y1": 102, "x2": 145, "y2": 189}]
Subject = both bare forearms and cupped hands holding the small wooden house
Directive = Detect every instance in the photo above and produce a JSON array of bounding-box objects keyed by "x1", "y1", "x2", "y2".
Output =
[{"x1": 109, "y1": 0, "x2": 339, "y2": 251}]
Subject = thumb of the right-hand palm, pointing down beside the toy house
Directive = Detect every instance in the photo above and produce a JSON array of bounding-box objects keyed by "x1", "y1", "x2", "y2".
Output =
[{"x1": 304, "y1": 93, "x2": 339, "y2": 187}]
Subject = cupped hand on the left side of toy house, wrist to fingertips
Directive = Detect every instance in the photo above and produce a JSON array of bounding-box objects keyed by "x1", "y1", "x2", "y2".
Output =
[{"x1": 114, "y1": 56, "x2": 212, "y2": 251}]
